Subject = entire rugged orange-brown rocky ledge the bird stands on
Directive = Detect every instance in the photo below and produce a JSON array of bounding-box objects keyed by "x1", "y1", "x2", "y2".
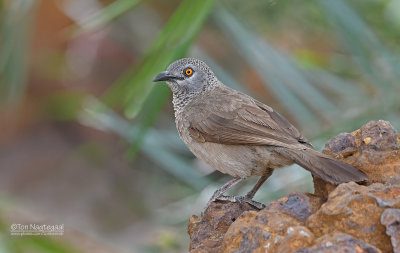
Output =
[{"x1": 189, "y1": 120, "x2": 400, "y2": 253}]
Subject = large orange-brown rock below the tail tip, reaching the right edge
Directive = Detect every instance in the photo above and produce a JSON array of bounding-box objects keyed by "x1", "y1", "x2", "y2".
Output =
[{"x1": 306, "y1": 182, "x2": 400, "y2": 252}]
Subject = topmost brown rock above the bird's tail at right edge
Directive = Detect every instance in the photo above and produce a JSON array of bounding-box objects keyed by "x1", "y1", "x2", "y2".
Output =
[{"x1": 322, "y1": 120, "x2": 400, "y2": 191}]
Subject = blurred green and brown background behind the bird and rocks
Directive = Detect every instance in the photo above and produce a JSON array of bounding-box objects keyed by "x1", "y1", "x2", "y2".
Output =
[{"x1": 0, "y1": 0, "x2": 400, "y2": 253}]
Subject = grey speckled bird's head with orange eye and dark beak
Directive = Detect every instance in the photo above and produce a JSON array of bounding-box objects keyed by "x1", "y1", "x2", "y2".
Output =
[{"x1": 153, "y1": 58, "x2": 219, "y2": 95}]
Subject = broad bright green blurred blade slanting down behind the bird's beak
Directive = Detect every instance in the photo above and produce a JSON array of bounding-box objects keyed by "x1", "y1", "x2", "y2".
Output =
[{"x1": 104, "y1": 0, "x2": 214, "y2": 118}]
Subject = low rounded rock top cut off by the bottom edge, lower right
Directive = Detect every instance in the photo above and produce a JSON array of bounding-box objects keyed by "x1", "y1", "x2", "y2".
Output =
[{"x1": 296, "y1": 233, "x2": 382, "y2": 253}]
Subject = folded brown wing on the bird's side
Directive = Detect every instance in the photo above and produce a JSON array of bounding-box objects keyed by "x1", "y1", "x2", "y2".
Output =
[{"x1": 189, "y1": 100, "x2": 312, "y2": 147}]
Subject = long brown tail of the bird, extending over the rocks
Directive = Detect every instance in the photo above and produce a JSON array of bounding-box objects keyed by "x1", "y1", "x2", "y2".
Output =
[{"x1": 279, "y1": 148, "x2": 369, "y2": 184}]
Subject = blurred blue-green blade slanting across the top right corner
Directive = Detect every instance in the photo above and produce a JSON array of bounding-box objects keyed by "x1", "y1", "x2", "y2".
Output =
[{"x1": 317, "y1": 0, "x2": 400, "y2": 94}]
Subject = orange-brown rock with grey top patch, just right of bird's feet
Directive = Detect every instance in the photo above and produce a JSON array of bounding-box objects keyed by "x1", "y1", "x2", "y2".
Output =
[{"x1": 222, "y1": 193, "x2": 321, "y2": 253}]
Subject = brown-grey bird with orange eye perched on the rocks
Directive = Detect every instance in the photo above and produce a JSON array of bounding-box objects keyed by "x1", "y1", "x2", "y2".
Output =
[{"x1": 153, "y1": 58, "x2": 368, "y2": 209}]
